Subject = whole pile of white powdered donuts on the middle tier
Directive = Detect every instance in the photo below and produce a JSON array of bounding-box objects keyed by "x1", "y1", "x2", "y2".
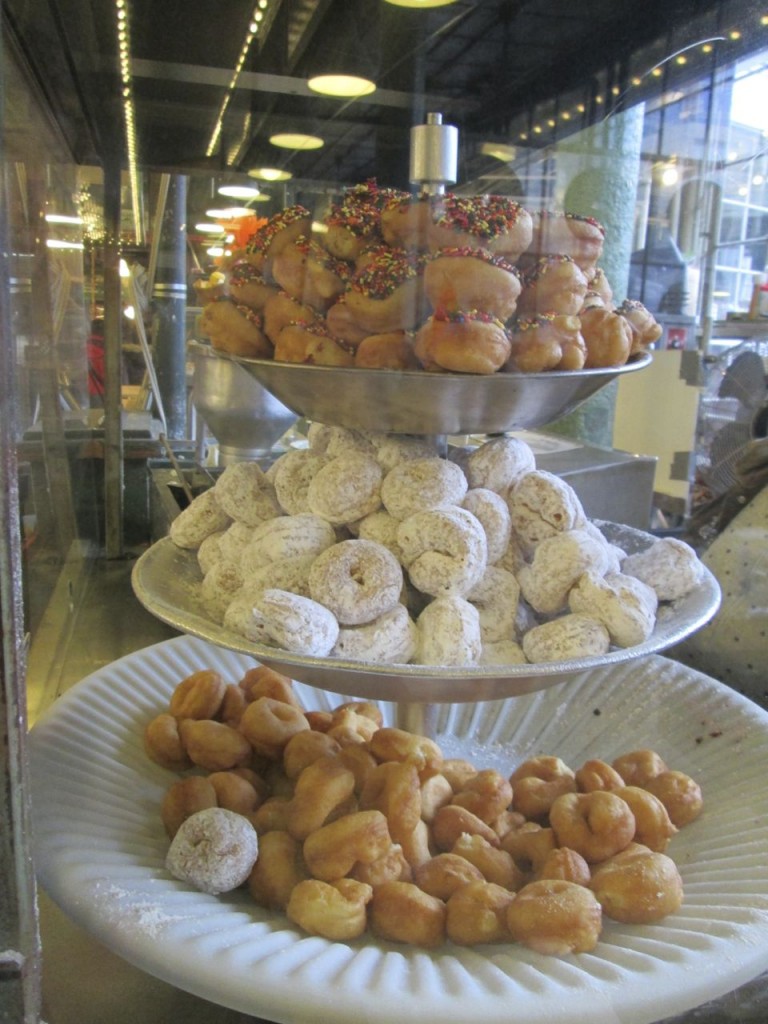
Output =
[{"x1": 170, "y1": 424, "x2": 703, "y2": 667}]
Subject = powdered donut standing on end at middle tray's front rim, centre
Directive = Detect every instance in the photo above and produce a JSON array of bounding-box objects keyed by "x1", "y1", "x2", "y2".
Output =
[{"x1": 414, "y1": 596, "x2": 482, "y2": 666}]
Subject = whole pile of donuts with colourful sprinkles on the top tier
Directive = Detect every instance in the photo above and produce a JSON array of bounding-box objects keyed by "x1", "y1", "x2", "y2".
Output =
[{"x1": 198, "y1": 181, "x2": 662, "y2": 375}]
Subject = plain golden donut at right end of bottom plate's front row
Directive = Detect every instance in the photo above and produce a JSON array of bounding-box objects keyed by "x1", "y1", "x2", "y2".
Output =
[{"x1": 590, "y1": 847, "x2": 683, "y2": 925}]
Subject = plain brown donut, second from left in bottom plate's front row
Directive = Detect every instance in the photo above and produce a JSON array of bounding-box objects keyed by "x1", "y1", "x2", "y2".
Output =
[{"x1": 369, "y1": 882, "x2": 446, "y2": 949}]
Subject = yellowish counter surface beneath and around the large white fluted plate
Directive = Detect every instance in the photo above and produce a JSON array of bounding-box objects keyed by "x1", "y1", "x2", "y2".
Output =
[{"x1": 29, "y1": 558, "x2": 768, "y2": 1024}]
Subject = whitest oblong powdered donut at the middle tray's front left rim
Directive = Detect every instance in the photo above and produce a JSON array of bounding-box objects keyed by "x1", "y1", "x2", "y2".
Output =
[{"x1": 253, "y1": 590, "x2": 339, "y2": 657}]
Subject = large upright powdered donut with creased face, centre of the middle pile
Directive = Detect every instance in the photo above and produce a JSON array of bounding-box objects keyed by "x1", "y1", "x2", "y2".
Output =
[{"x1": 397, "y1": 506, "x2": 487, "y2": 597}]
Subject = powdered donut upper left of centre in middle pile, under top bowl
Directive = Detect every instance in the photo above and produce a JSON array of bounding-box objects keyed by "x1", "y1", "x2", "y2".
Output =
[{"x1": 306, "y1": 451, "x2": 384, "y2": 526}]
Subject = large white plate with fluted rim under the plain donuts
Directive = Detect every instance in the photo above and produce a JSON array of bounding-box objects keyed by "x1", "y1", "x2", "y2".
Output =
[{"x1": 31, "y1": 637, "x2": 768, "y2": 1024}]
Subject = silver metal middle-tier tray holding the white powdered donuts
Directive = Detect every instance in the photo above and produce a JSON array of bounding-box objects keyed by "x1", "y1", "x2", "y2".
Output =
[{"x1": 132, "y1": 522, "x2": 720, "y2": 705}]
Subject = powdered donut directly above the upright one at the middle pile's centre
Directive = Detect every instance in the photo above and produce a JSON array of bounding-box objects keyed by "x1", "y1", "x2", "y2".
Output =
[{"x1": 381, "y1": 456, "x2": 467, "y2": 520}]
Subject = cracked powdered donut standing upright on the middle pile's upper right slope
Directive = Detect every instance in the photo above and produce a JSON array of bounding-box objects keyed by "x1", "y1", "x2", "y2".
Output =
[{"x1": 508, "y1": 469, "x2": 587, "y2": 553}]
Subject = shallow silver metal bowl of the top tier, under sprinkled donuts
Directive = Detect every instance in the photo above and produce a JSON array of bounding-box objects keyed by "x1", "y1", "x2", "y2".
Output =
[{"x1": 225, "y1": 353, "x2": 651, "y2": 435}]
